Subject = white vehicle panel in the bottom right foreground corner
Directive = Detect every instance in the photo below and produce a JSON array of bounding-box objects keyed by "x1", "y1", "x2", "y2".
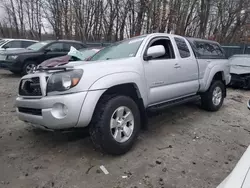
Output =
[{"x1": 217, "y1": 146, "x2": 250, "y2": 188}]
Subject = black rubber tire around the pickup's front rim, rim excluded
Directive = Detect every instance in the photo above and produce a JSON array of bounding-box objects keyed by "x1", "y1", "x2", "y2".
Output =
[{"x1": 89, "y1": 96, "x2": 141, "y2": 155}]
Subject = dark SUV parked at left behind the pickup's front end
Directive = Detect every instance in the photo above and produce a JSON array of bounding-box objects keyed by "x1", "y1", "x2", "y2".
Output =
[{"x1": 0, "y1": 40, "x2": 86, "y2": 75}]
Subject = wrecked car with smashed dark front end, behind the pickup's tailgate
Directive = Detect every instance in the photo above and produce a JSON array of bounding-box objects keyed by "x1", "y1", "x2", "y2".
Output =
[{"x1": 229, "y1": 55, "x2": 250, "y2": 89}]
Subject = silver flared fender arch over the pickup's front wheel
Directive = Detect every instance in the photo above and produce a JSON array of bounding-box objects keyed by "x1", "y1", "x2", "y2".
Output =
[{"x1": 88, "y1": 72, "x2": 148, "y2": 106}]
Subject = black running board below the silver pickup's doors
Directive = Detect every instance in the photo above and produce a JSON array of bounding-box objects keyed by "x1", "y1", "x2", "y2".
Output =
[{"x1": 148, "y1": 95, "x2": 200, "y2": 111}]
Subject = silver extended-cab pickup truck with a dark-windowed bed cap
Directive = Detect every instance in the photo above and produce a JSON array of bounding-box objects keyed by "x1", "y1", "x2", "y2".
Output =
[{"x1": 16, "y1": 33, "x2": 231, "y2": 154}]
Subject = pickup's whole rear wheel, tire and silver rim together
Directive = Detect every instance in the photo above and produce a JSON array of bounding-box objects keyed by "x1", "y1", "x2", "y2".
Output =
[{"x1": 201, "y1": 80, "x2": 226, "y2": 112}]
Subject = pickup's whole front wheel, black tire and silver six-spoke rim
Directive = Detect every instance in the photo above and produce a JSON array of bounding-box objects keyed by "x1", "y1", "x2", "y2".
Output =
[{"x1": 90, "y1": 96, "x2": 140, "y2": 155}]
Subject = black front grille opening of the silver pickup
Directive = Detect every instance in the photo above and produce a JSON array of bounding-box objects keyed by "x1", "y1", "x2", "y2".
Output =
[{"x1": 19, "y1": 77, "x2": 42, "y2": 96}]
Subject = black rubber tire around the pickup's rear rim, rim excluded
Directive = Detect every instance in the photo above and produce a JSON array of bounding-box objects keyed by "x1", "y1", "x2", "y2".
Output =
[{"x1": 201, "y1": 80, "x2": 226, "y2": 112}]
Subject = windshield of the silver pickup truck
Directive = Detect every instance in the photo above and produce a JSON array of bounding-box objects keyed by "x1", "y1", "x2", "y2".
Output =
[{"x1": 89, "y1": 36, "x2": 145, "y2": 61}]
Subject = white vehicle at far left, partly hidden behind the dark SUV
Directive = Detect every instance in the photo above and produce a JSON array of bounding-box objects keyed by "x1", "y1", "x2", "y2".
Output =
[{"x1": 0, "y1": 39, "x2": 38, "y2": 51}]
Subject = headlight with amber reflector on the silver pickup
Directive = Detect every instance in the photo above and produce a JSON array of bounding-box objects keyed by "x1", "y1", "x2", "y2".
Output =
[{"x1": 47, "y1": 69, "x2": 83, "y2": 93}]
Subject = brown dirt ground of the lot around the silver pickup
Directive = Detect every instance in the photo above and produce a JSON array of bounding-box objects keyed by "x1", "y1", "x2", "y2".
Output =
[{"x1": 0, "y1": 70, "x2": 250, "y2": 188}]
